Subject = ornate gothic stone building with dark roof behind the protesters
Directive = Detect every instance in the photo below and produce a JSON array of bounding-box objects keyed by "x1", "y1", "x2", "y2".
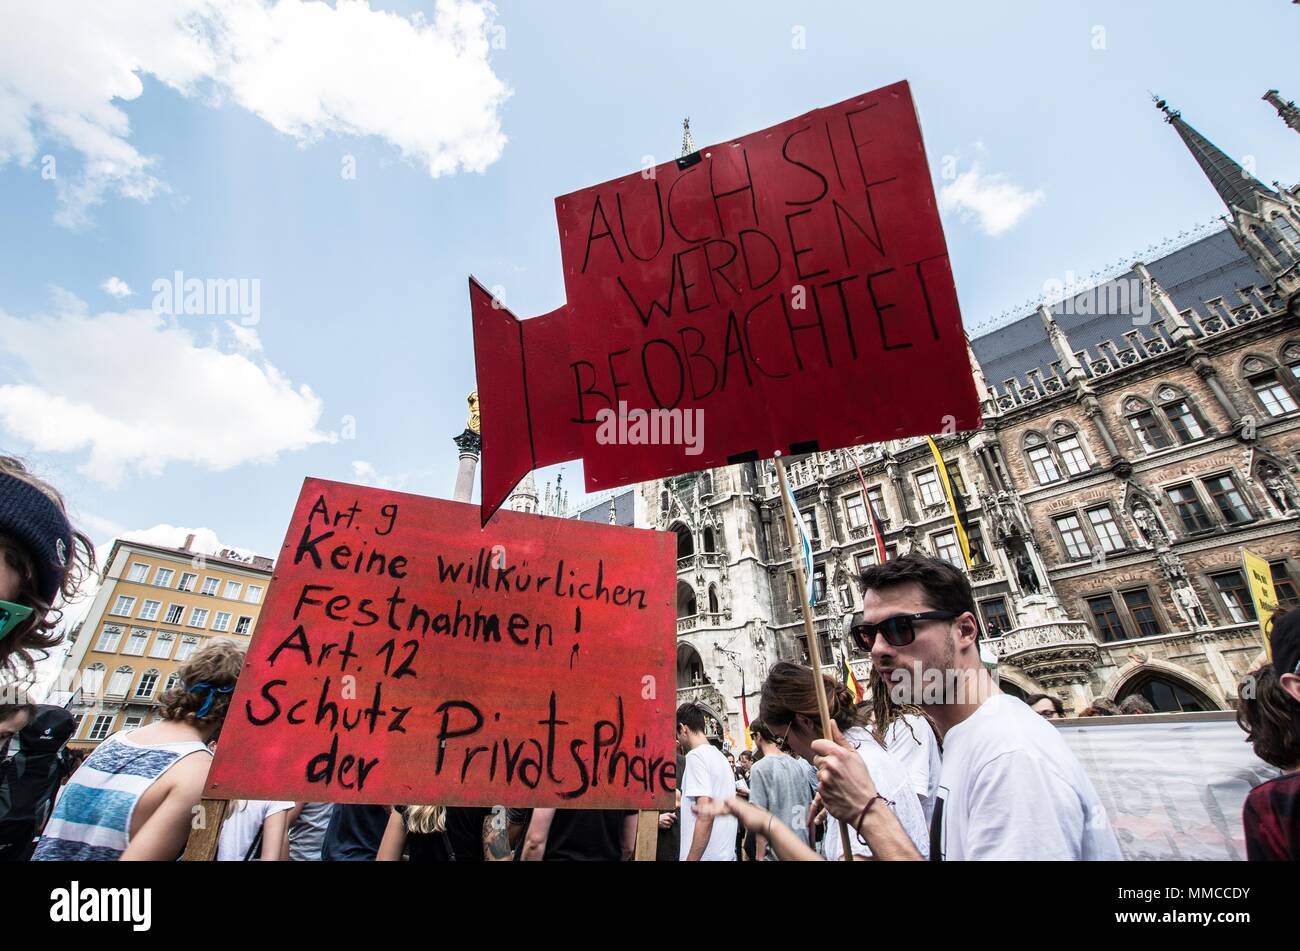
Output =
[{"x1": 647, "y1": 92, "x2": 1300, "y2": 742}]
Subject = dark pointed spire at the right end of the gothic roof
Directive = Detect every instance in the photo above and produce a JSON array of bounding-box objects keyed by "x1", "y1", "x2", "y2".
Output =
[{"x1": 1152, "y1": 96, "x2": 1300, "y2": 298}]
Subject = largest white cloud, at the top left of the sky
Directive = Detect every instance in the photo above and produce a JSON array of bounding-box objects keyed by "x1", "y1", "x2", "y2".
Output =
[{"x1": 0, "y1": 0, "x2": 510, "y2": 227}]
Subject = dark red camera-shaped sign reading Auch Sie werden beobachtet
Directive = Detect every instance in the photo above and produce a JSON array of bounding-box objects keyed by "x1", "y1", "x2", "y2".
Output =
[{"x1": 471, "y1": 82, "x2": 980, "y2": 520}]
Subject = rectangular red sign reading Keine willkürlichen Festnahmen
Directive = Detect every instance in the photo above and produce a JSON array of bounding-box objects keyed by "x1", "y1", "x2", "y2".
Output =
[{"x1": 205, "y1": 479, "x2": 676, "y2": 809}]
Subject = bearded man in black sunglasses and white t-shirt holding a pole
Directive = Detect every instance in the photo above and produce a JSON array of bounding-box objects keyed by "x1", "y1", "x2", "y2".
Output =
[{"x1": 813, "y1": 555, "x2": 1122, "y2": 861}]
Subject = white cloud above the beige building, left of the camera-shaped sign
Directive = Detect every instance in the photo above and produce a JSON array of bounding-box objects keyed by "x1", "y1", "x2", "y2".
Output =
[{"x1": 0, "y1": 296, "x2": 337, "y2": 485}]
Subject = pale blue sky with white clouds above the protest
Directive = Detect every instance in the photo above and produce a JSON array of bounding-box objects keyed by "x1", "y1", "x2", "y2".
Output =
[{"x1": 0, "y1": 0, "x2": 1300, "y2": 571}]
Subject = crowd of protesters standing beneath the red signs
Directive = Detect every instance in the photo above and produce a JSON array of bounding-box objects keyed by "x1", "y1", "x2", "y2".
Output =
[{"x1": 0, "y1": 446, "x2": 1300, "y2": 861}]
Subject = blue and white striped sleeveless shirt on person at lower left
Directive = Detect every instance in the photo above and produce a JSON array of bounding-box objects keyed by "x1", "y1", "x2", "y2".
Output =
[{"x1": 33, "y1": 733, "x2": 208, "y2": 861}]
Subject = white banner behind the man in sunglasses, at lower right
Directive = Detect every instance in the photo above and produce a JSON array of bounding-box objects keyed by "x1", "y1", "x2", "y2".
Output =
[{"x1": 1054, "y1": 712, "x2": 1278, "y2": 861}]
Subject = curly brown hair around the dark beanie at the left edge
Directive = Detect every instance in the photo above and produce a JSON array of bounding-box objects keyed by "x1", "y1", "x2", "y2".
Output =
[{"x1": 0, "y1": 456, "x2": 95, "y2": 672}]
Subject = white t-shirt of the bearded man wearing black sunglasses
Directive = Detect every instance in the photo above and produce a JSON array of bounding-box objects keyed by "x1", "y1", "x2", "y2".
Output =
[{"x1": 935, "y1": 694, "x2": 1123, "y2": 861}]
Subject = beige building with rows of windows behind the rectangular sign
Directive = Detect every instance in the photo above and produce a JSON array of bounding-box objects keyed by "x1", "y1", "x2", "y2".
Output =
[{"x1": 59, "y1": 535, "x2": 274, "y2": 748}]
